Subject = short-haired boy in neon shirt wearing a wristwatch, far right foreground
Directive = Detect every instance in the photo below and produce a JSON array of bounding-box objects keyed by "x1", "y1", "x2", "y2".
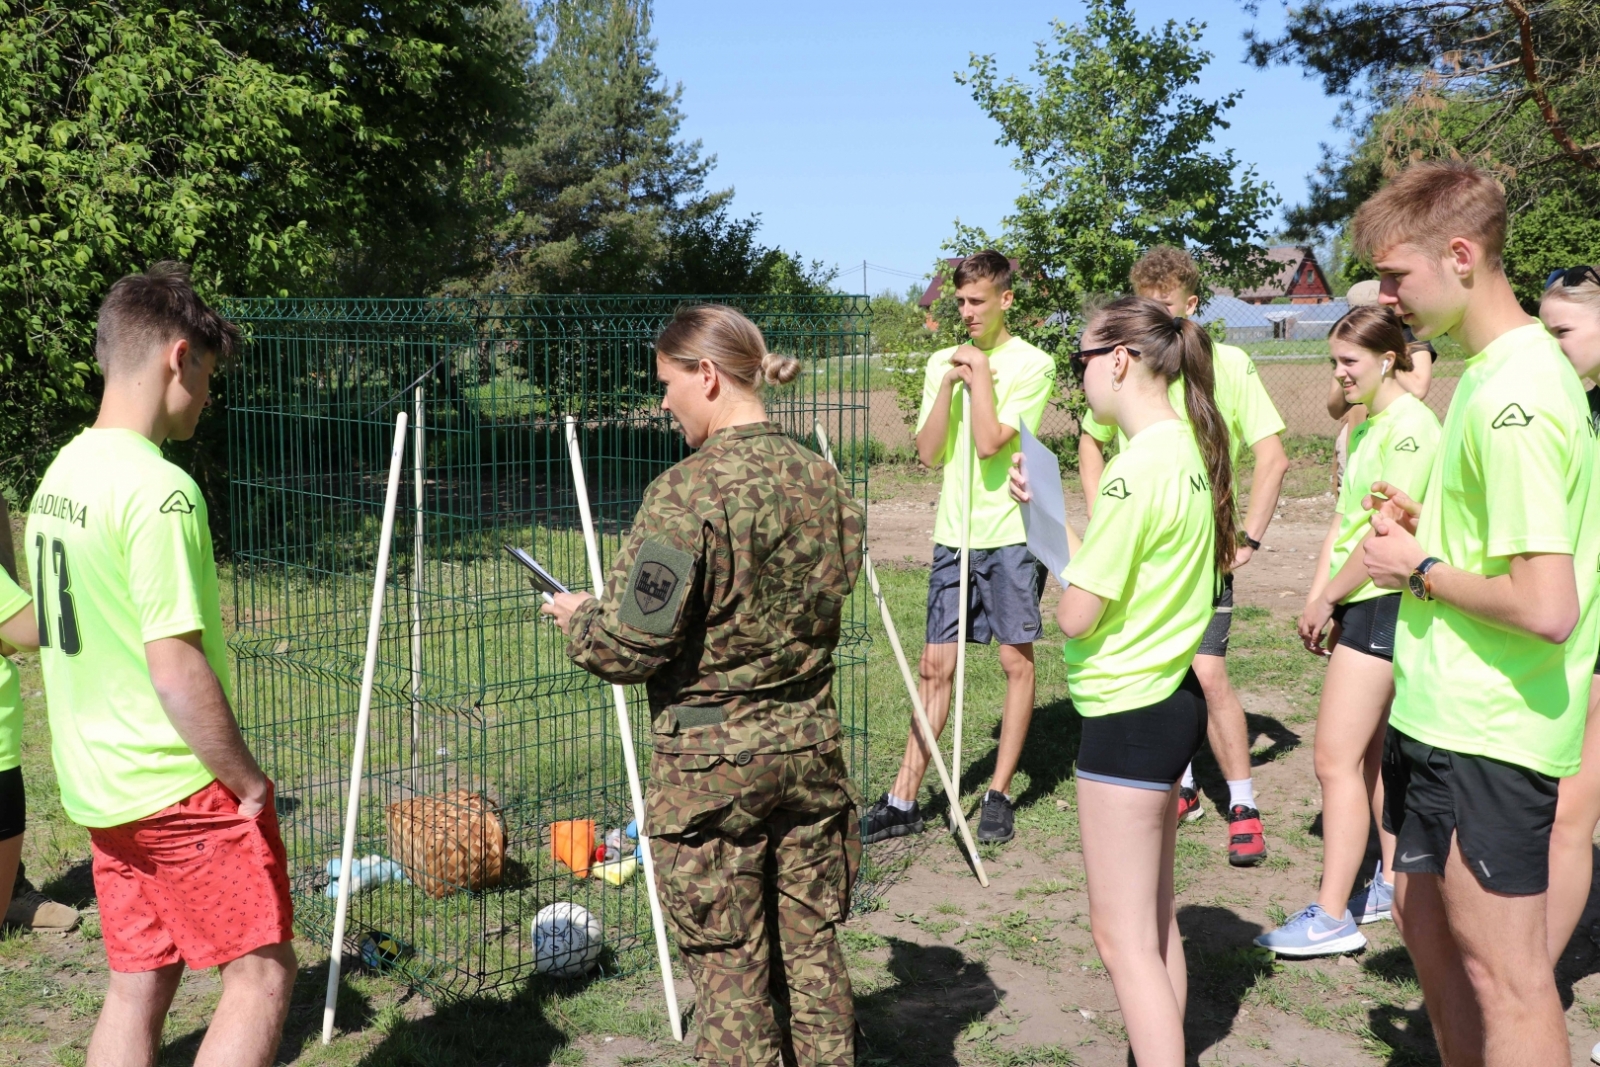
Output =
[{"x1": 1352, "y1": 163, "x2": 1600, "y2": 1067}]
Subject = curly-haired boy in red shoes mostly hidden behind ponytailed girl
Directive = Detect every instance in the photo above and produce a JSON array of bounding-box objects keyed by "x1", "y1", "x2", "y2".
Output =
[{"x1": 1078, "y1": 245, "x2": 1290, "y2": 867}]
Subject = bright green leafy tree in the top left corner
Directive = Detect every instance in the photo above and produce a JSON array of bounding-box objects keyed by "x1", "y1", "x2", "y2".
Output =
[{"x1": 0, "y1": 0, "x2": 358, "y2": 491}]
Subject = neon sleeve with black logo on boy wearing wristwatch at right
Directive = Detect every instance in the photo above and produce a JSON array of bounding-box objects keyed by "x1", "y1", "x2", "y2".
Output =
[{"x1": 1467, "y1": 390, "x2": 1590, "y2": 557}]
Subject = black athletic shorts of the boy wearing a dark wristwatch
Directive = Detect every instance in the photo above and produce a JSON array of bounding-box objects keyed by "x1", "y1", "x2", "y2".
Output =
[{"x1": 1384, "y1": 726, "x2": 1558, "y2": 896}]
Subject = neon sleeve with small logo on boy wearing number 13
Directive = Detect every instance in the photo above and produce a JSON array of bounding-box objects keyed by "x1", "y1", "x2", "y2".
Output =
[{"x1": 122, "y1": 467, "x2": 214, "y2": 643}]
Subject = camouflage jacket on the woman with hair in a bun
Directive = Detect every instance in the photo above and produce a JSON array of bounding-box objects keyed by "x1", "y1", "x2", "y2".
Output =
[{"x1": 566, "y1": 422, "x2": 864, "y2": 763}]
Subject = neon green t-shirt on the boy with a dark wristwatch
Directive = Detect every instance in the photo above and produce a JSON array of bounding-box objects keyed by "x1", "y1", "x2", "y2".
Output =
[{"x1": 1389, "y1": 323, "x2": 1600, "y2": 777}]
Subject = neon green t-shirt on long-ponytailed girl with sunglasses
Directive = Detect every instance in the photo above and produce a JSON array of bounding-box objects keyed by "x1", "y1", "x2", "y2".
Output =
[{"x1": 1066, "y1": 419, "x2": 1216, "y2": 717}]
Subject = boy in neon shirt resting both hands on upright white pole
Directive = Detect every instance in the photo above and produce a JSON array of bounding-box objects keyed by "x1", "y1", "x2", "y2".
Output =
[{"x1": 862, "y1": 251, "x2": 1056, "y2": 843}]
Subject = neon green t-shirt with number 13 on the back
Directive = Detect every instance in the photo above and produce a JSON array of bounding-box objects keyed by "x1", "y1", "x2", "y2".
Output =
[{"x1": 27, "y1": 429, "x2": 229, "y2": 827}]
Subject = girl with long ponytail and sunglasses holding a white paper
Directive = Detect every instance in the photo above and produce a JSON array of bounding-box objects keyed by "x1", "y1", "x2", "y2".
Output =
[{"x1": 1011, "y1": 296, "x2": 1235, "y2": 1067}]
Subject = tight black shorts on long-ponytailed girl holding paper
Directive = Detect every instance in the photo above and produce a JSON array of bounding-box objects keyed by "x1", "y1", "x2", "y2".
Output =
[{"x1": 1077, "y1": 667, "x2": 1206, "y2": 790}]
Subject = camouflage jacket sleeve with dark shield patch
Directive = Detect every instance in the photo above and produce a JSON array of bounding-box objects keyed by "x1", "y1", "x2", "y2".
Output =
[{"x1": 566, "y1": 472, "x2": 707, "y2": 685}]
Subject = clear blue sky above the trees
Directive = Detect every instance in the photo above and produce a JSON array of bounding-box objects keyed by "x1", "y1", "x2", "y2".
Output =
[{"x1": 654, "y1": 0, "x2": 1346, "y2": 293}]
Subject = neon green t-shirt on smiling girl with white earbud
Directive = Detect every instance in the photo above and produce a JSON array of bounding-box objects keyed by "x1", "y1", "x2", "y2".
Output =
[{"x1": 1328, "y1": 392, "x2": 1440, "y2": 603}]
